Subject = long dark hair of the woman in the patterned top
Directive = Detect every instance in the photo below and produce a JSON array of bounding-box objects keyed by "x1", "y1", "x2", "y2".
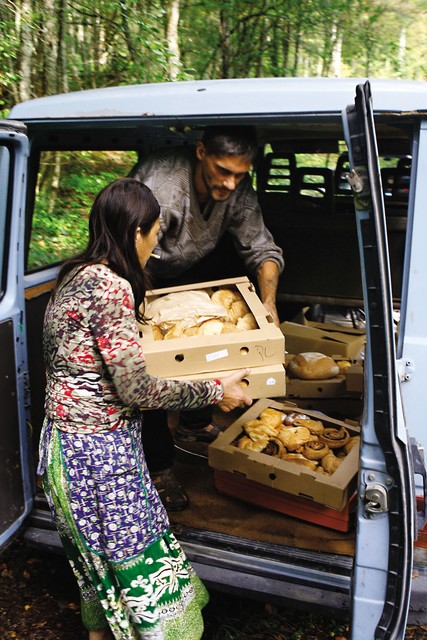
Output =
[{"x1": 57, "y1": 178, "x2": 160, "y2": 321}]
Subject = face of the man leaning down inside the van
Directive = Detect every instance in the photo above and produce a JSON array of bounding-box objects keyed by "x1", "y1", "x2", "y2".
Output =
[{"x1": 195, "y1": 142, "x2": 251, "y2": 202}]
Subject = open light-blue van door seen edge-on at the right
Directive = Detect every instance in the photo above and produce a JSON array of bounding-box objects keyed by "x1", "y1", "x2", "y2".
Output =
[{"x1": 343, "y1": 83, "x2": 416, "y2": 640}]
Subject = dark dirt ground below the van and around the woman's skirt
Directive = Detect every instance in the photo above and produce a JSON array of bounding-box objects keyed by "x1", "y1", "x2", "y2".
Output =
[{"x1": 0, "y1": 538, "x2": 427, "y2": 640}]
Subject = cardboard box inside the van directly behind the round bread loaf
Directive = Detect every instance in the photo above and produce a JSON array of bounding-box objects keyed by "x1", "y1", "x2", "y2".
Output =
[{"x1": 280, "y1": 313, "x2": 366, "y2": 361}]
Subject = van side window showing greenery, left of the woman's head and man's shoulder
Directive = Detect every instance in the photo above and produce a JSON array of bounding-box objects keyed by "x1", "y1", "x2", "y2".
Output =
[{"x1": 26, "y1": 151, "x2": 136, "y2": 272}]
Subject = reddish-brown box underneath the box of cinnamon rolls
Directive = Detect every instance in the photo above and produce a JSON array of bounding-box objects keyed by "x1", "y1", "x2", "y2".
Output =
[{"x1": 214, "y1": 469, "x2": 356, "y2": 532}]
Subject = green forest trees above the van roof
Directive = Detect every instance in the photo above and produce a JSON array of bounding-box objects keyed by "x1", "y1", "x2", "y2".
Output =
[{"x1": 0, "y1": 0, "x2": 427, "y2": 116}]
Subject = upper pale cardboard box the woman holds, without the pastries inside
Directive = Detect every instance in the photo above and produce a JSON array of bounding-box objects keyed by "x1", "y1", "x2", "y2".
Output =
[{"x1": 139, "y1": 277, "x2": 285, "y2": 378}]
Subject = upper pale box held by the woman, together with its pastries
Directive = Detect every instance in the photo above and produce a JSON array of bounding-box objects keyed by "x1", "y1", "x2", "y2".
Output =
[{"x1": 139, "y1": 277, "x2": 285, "y2": 378}]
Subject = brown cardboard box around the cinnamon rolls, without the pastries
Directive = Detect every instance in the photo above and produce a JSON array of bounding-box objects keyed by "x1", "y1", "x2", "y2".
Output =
[{"x1": 208, "y1": 398, "x2": 360, "y2": 510}]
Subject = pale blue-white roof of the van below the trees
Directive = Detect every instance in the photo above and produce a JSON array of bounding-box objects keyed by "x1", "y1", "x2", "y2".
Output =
[{"x1": 10, "y1": 78, "x2": 427, "y2": 121}]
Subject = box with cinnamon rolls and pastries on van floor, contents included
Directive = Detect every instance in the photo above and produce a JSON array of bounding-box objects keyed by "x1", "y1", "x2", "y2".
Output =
[{"x1": 208, "y1": 398, "x2": 360, "y2": 510}]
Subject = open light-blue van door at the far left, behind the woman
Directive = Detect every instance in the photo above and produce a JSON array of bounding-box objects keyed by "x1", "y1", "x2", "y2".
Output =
[{"x1": 0, "y1": 120, "x2": 34, "y2": 548}]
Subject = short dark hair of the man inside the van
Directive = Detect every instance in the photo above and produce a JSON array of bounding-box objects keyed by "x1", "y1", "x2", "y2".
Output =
[{"x1": 202, "y1": 126, "x2": 257, "y2": 161}]
